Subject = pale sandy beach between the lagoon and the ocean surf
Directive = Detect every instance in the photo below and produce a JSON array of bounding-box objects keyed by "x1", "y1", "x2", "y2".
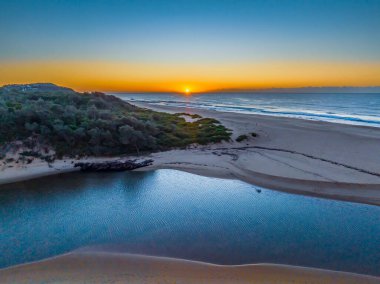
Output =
[{"x1": 0, "y1": 104, "x2": 380, "y2": 205}]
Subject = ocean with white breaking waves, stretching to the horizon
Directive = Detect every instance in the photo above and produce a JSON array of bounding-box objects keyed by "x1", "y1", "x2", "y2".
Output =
[{"x1": 114, "y1": 93, "x2": 380, "y2": 127}]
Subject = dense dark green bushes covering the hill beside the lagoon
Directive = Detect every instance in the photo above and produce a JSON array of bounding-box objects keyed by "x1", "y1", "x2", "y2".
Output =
[{"x1": 0, "y1": 85, "x2": 231, "y2": 157}]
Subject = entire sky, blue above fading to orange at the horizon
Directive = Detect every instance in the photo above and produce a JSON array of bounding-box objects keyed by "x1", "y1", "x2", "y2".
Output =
[{"x1": 0, "y1": 0, "x2": 380, "y2": 92}]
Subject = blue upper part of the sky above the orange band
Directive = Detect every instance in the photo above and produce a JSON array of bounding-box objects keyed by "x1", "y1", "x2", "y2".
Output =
[{"x1": 0, "y1": 0, "x2": 380, "y2": 62}]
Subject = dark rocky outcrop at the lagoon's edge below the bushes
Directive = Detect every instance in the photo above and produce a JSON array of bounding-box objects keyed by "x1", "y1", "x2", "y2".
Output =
[{"x1": 74, "y1": 160, "x2": 153, "y2": 172}]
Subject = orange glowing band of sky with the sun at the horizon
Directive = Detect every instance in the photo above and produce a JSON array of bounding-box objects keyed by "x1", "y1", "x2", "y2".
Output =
[{"x1": 0, "y1": 61, "x2": 380, "y2": 94}]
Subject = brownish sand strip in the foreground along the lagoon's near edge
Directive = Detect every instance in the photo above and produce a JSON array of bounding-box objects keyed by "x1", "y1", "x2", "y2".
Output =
[{"x1": 0, "y1": 248, "x2": 380, "y2": 284}]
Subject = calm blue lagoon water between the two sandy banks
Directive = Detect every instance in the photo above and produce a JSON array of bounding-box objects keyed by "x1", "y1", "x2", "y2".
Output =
[{"x1": 0, "y1": 170, "x2": 380, "y2": 275}]
